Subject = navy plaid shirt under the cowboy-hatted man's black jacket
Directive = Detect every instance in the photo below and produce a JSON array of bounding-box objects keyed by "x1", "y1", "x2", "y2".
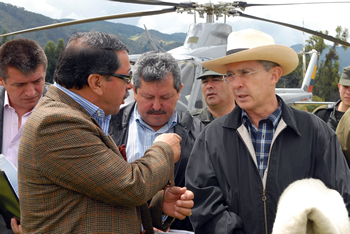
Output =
[{"x1": 242, "y1": 104, "x2": 282, "y2": 178}]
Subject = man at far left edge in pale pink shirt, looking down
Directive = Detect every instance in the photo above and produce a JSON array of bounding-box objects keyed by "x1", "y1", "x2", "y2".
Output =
[{"x1": 0, "y1": 39, "x2": 47, "y2": 233}]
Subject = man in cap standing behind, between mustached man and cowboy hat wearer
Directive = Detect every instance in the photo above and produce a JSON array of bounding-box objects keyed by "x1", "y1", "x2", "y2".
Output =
[{"x1": 190, "y1": 68, "x2": 235, "y2": 125}]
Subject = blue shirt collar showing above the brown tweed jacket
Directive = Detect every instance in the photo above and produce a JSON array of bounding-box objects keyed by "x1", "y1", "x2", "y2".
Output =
[{"x1": 54, "y1": 83, "x2": 111, "y2": 135}]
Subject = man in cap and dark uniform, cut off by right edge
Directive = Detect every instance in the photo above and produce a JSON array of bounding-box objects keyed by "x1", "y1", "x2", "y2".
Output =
[{"x1": 314, "y1": 66, "x2": 350, "y2": 131}]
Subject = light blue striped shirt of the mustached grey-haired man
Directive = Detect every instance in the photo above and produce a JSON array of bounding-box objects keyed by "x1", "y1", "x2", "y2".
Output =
[{"x1": 126, "y1": 103, "x2": 177, "y2": 162}]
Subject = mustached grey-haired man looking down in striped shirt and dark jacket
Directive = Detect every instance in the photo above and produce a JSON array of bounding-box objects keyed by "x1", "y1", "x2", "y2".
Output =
[{"x1": 109, "y1": 51, "x2": 203, "y2": 230}]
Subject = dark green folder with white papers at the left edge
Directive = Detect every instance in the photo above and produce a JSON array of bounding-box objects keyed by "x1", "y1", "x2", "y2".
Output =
[{"x1": 0, "y1": 154, "x2": 20, "y2": 228}]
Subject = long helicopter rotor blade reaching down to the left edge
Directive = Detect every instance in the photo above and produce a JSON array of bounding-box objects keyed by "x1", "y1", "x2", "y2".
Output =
[{"x1": 0, "y1": 7, "x2": 176, "y2": 37}]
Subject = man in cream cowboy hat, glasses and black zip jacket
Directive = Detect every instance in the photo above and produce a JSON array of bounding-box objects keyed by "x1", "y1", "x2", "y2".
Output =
[{"x1": 185, "y1": 29, "x2": 350, "y2": 234}]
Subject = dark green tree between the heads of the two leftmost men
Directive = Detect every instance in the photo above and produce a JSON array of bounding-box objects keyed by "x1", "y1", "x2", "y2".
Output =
[{"x1": 44, "y1": 38, "x2": 64, "y2": 83}]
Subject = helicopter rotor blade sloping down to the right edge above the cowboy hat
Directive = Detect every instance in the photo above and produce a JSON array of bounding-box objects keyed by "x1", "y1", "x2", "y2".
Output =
[{"x1": 229, "y1": 11, "x2": 350, "y2": 47}]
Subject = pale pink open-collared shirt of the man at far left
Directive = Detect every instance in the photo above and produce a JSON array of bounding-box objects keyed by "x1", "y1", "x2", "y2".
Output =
[{"x1": 2, "y1": 91, "x2": 34, "y2": 168}]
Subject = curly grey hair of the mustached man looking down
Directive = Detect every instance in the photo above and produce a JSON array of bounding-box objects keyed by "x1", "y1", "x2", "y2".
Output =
[{"x1": 133, "y1": 51, "x2": 181, "y2": 92}]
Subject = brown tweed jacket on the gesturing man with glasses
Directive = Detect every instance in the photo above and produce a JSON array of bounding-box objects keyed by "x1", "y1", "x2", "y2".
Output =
[{"x1": 18, "y1": 86, "x2": 174, "y2": 233}]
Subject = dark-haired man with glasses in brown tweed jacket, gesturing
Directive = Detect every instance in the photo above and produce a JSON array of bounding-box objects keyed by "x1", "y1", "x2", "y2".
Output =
[{"x1": 18, "y1": 32, "x2": 193, "y2": 233}]
